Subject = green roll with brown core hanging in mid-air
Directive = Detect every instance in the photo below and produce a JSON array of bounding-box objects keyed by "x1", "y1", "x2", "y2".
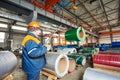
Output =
[{"x1": 65, "y1": 27, "x2": 86, "y2": 41}]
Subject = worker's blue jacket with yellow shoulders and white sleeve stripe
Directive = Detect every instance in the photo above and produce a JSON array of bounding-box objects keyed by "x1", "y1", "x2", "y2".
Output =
[{"x1": 22, "y1": 33, "x2": 47, "y2": 73}]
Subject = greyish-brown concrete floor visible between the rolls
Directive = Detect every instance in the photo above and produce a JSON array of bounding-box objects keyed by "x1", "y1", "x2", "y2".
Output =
[{"x1": 13, "y1": 57, "x2": 90, "y2": 80}]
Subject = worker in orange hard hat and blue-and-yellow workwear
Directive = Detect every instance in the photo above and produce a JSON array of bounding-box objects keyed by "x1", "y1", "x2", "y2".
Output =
[{"x1": 22, "y1": 21, "x2": 47, "y2": 80}]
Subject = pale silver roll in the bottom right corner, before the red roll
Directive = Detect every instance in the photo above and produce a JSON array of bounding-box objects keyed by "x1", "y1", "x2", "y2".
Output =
[{"x1": 83, "y1": 68, "x2": 120, "y2": 80}]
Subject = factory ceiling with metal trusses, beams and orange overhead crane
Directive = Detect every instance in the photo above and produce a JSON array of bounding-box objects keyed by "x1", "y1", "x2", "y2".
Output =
[{"x1": 0, "y1": 0, "x2": 120, "y2": 33}]
